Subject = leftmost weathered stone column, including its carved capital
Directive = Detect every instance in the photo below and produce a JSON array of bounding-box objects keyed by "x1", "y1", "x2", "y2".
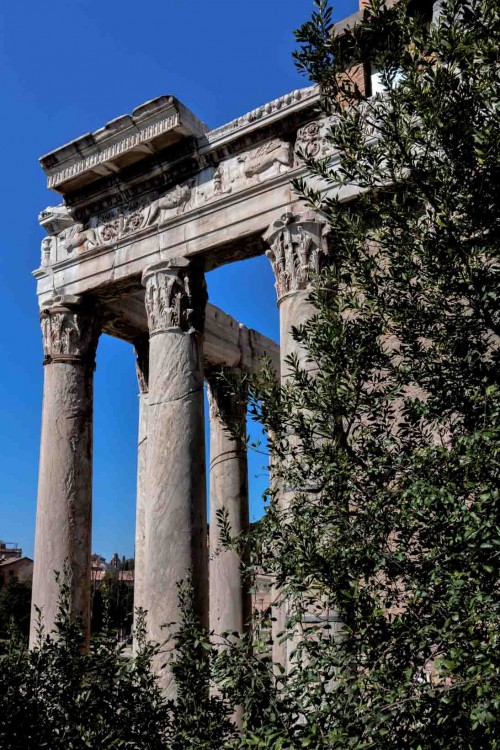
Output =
[{"x1": 30, "y1": 297, "x2": 100, "y2": 646}]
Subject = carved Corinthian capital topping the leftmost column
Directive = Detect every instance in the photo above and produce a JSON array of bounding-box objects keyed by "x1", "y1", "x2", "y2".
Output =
[{"x1": 40, "y1": 297, "x2": 100, "y2": 364}]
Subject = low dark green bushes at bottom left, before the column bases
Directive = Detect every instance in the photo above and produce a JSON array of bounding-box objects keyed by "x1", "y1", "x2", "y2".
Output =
[{"x1": 0, "y1": 581, "x2": 232, "y2": 750}]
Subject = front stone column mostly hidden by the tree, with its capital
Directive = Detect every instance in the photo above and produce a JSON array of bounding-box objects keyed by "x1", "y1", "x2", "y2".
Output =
[{"x1": 264, "y1": 211, "x2": 327, "y2": 667}]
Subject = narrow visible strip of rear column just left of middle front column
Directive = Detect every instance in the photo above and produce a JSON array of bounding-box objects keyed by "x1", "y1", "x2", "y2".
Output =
[{"x1": 134, "y1": 336, "x2": 149, "y2": 650}]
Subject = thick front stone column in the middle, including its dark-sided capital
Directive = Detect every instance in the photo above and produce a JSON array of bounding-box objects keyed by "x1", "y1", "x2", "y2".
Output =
[{"x1": 143, "y1": 258, "x2": 208, "y2": 697}]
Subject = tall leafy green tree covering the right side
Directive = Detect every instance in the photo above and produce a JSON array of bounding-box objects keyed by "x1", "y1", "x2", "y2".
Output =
[{"x1": 214, "y1": 0, "x2": 500, "y2": 750}]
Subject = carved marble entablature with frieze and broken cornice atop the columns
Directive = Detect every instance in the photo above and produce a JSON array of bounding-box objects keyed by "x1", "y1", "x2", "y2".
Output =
[{"x1": 34, "y1": 87, "x2": 356, "y2": 300}]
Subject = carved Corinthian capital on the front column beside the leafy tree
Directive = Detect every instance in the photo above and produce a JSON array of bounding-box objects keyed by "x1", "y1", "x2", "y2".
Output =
[{"x1": 264, "y1": 211, "x2": 328, "y2": 304}]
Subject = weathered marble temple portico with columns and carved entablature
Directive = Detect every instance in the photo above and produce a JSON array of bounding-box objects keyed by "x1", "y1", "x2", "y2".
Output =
[{"x1": 32, "y1": 87, "x2": 344, "y2": 695}]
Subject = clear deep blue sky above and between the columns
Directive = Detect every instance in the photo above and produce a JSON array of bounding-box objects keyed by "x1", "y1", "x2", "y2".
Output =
[{"x1": 0, "y1": 0, "x2": 357, "y2": 558}]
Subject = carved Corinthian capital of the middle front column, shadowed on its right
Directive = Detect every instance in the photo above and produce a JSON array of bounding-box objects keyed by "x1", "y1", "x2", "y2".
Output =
[{"x1": 142, "y1": 258, "x2": 207, "y2": 336}]
